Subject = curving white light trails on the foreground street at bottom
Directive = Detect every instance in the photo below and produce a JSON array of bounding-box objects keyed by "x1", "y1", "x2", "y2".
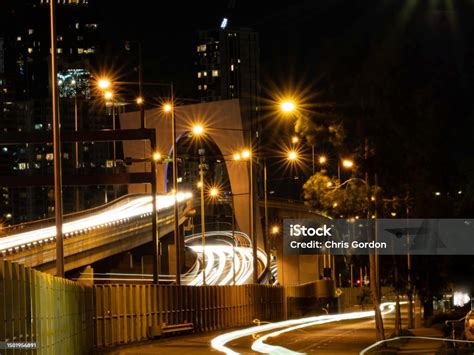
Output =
[{"x1": 211, "y1": 302, "x2": 404, "y2": 355}]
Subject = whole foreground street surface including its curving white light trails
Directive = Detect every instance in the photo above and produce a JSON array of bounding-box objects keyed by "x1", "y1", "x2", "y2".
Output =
[{"x1": 99, "y1": 306, "x2": 404, "y2": 355}]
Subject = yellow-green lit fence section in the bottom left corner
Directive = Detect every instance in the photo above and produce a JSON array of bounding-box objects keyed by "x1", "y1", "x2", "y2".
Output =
[{"x1": 0, "y1": 260, "x2": 94, "y2": 355}]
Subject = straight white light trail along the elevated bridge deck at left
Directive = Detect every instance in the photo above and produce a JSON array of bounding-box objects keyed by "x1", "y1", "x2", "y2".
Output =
[{"x1": 0, "y1": 192, "x2": 192, "y2": 253}]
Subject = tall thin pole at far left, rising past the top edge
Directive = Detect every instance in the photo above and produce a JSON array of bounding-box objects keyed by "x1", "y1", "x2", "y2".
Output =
[{"x1": 49, "y1": 1, "x2": 64, "y2": 277}]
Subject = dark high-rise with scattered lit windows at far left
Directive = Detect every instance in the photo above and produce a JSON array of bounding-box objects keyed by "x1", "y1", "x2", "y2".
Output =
[{"x1": 0, "y1": 0, "x2": 108, "y2": 224}]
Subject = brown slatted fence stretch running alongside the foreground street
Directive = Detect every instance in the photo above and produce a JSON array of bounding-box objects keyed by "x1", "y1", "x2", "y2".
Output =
[{"x1": 94, "y1": 284, "x2": 315, "y2": 347}]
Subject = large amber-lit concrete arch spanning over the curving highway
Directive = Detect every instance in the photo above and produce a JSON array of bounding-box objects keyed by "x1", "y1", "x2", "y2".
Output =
[{"x1": 120, "y1": 99, "x2": 263, "y2": 248}]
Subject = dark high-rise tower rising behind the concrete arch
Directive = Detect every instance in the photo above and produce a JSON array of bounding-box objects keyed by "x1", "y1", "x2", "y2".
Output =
[{"x1": 196, "y1": 26, "x2": 260, "y2": 132}]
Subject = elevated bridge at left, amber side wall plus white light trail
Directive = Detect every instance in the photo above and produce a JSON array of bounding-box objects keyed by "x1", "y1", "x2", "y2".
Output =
[{"x1": 0, "y1": 194, "x2": 191, "y2": 273}]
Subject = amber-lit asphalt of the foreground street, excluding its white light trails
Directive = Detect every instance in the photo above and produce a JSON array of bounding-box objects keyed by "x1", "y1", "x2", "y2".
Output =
[{"x1": 98, "y1": 304, "x2": 403, "y2": 355}]
